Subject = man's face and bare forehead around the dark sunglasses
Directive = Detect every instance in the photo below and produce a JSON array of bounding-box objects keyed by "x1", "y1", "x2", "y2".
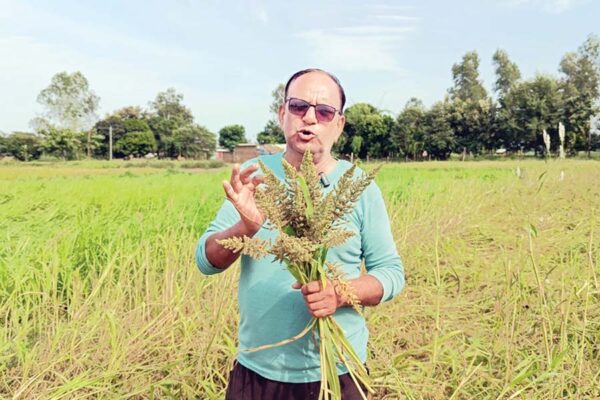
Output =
[{"x1": 279, "y1": 72, "x2": 346, "y2": 158}]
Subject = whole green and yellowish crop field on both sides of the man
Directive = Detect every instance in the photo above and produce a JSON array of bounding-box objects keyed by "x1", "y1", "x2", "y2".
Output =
[{"x1": 0, "y1": 160, "x2": 600, "y2": 399}]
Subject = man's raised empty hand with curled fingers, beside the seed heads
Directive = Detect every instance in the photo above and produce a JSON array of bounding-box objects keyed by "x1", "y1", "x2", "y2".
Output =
[{"x1": 223, "y1": 164, "x2": 265, "y2": 232}]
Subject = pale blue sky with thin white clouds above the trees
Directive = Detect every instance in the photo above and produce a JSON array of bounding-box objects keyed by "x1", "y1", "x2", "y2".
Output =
[{"x1": 0, "y1": 0, "x2": 600, "y2": 141}]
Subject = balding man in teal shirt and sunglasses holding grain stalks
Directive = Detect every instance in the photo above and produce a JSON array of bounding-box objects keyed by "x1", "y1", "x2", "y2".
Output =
[{"x1": 196, "y1": 69, "x2": 404, "y2": 400}]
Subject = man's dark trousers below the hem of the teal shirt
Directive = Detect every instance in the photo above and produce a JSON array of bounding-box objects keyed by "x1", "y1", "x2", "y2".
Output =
[{"x1": 225, "y1": 361, "x2": 367, "y2": 400}]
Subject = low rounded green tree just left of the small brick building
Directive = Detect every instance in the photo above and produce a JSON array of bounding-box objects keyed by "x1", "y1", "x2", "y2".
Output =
[{"x1": 173, "y1": 124, "x2": 217, "y2": 159}]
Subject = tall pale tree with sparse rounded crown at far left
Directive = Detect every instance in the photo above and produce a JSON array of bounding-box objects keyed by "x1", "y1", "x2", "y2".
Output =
[{"x1": 37, "y1": 71, "x2": 100, "y2": 132}]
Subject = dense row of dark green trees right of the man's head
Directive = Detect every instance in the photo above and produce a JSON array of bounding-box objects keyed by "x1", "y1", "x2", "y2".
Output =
[{"x1": 336, "y1": 35, "x2": 600, "y2": 160}]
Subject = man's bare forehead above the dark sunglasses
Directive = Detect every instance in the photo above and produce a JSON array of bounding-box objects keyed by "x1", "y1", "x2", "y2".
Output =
[{"x1": 288, "y1": 71, "x2": 341, "y2": 107}]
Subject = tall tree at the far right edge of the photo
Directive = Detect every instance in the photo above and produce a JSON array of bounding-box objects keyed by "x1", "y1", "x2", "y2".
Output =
[{"x1": 560, "y1": 35, "x2": 600, "y2": 152}]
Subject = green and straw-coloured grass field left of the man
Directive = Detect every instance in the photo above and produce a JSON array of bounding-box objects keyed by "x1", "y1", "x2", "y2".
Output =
[{"x1": 0, "y1": 165, "x2": 237, "y2": 399}]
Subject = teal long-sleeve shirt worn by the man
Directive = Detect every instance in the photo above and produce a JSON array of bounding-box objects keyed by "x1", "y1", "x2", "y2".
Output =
[{"x1": 196, "y1": 153, "x2": 404, "y2": 383}]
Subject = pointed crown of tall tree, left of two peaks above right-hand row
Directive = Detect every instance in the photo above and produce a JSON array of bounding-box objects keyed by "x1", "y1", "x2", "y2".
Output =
[{"x1": 448, "y1": 51, "x2": 487, "y2": 102}]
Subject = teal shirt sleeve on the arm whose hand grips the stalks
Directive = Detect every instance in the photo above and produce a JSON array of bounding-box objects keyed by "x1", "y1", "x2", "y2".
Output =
[{"x1": 359, "y1": 182, "x2": 404, "y2": 302}]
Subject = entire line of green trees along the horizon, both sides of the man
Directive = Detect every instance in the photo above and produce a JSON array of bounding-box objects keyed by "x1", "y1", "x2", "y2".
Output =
[{"x1": 0, "y1": 35, "x2": 600, "y2": 160}]
